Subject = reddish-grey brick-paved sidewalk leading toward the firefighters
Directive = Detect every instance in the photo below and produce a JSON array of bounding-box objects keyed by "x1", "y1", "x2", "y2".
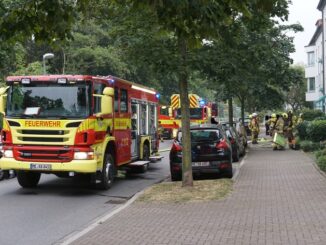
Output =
[{"x1": 67, "y1": 143, "x2": 326, "y2": 245}]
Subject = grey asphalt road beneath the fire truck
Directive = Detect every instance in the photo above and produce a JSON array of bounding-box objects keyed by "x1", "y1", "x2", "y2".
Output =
[{"x1": 0, "y1": 141, "x2": 171, "y2": 245}]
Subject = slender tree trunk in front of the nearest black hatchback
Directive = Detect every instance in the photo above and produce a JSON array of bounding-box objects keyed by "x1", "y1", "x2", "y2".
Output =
[{"x1": 178, "y1": 36, "x2": 193, "y2": 187}]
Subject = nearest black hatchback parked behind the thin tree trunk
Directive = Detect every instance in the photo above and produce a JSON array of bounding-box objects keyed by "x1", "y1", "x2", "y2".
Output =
[{"x1": 170, "y1": 124, "x2": 233, "y2": 181}]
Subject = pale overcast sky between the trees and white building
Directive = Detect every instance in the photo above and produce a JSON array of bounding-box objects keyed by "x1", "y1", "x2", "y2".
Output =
[{"x1": 289, "y1": 0, "x2": 321, "y2": 64}]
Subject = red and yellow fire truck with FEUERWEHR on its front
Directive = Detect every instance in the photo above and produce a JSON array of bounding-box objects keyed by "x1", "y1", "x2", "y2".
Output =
[{"x1": 0, "y1": 75, "x2": 161, "y2": 189}]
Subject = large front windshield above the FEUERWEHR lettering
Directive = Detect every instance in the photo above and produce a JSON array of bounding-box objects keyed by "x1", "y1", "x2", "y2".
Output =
[{"x1": 6, "y1": 82, "x2": 90, "y2": 119}]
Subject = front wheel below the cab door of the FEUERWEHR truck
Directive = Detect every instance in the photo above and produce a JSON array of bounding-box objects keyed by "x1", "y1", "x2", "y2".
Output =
[{"x1": 99, "y1": 153, "x2": 115, "y2": 190}]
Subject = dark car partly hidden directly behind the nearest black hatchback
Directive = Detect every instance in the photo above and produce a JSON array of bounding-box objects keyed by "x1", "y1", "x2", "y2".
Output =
[{"x1": 223, "y1": 124, "x2": 246, "y2": 162}]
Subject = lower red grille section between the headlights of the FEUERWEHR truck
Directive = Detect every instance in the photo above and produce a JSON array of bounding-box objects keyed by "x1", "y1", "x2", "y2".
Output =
[{"x1": 14, "y1": 146, "x2": 73, "y2": 162}]
